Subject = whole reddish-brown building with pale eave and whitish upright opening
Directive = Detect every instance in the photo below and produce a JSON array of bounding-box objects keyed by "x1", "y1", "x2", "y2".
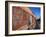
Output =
[{"x1": 12, "y1": 6, "x2": 36, "y2": 30}]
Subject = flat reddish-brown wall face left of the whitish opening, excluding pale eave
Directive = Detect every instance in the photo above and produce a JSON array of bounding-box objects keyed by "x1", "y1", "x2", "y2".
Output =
[{"x1": 12, "y1": 7, "x2": 29, "y2": 30}]
